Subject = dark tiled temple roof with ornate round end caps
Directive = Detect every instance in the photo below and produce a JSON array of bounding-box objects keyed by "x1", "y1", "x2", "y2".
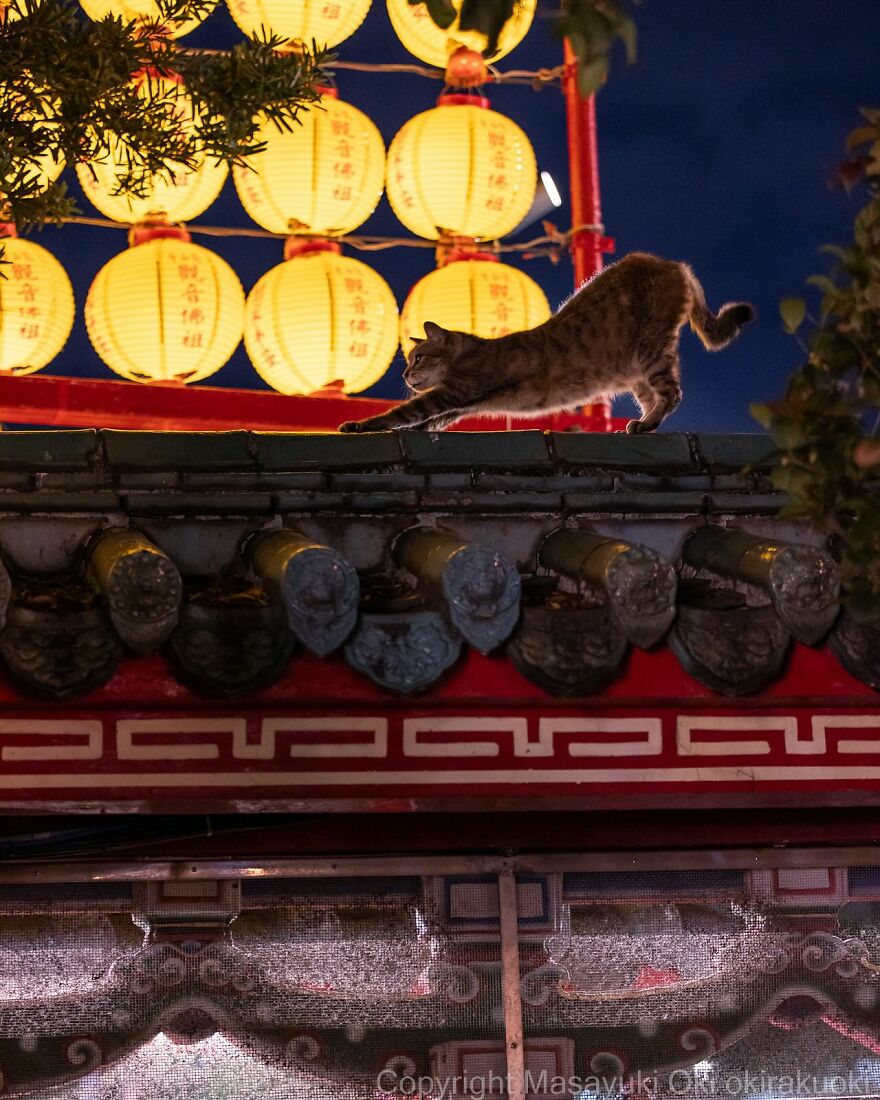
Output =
[{"x1": 0, "y1": 430, "x2": 880, "y2": 699}]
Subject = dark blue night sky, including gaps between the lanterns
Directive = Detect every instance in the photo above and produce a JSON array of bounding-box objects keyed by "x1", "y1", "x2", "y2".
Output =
[{"x1": 37, "y1": 0, "x2": 880, "y2": 431}]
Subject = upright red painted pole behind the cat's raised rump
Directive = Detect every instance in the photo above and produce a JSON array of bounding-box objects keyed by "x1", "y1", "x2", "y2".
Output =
[{"x1": 563, "y1": 40, "x2": 614, "y2": 431}]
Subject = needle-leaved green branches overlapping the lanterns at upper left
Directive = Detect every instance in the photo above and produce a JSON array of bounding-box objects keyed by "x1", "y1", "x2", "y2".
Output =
[{"x1": 0, "y1": 0, "x2": 330, "y2": 227}]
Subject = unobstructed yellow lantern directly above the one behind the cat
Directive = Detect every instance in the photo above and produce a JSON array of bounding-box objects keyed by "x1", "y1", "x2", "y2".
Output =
[{"x1": 386, "y1": 95, "x2": 537, "y2": 240}]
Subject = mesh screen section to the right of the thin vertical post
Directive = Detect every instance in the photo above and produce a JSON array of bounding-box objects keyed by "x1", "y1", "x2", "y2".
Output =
[{"x1": 520, "y1": 868, "x2": 880, "y2": 1100}]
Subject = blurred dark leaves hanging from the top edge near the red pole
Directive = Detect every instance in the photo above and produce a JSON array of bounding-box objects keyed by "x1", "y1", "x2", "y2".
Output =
[{"x1": 409, "y1": 0, "x2": 640, "y2": 96}]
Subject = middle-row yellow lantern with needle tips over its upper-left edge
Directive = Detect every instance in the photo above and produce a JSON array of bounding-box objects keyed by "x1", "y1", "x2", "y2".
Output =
[{"x1": 232, "y1": 89, "x2": 385, "y2": 237}]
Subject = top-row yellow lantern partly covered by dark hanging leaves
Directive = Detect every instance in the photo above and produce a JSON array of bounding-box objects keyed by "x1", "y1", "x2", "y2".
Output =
[{"x1": 388, "y1": 0, "x2": 538, "y2": 68}]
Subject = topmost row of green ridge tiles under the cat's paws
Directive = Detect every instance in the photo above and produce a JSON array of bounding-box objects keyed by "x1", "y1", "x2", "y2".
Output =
[{"x1": 0, "y1": 429, "x2": 773, "y2": 475}]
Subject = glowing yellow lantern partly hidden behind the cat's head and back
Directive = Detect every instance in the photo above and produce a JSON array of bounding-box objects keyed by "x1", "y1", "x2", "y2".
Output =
[{"x1": 400, "y1": 253, "x2": 550, "y2": 355}]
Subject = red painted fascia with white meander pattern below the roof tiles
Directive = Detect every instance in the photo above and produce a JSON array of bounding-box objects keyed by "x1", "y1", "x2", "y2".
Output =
[{"x1": 0, "y1": 646, "x2": 880, "y2": 813}]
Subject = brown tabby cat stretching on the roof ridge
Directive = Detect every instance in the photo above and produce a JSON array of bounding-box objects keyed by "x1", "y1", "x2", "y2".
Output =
[{"x1": 339, "y1": 252, "x2": 755, "y2": 432}]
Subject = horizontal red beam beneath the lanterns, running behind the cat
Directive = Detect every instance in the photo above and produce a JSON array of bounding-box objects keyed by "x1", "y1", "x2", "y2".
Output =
[{"x1": 0, "y1": 374, "x2": 625, "y2": 431}]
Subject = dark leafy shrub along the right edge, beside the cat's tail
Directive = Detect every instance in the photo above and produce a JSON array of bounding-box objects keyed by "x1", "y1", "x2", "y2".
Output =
[{"x1": 752, "y1": 110, "x2": 880, "y2": 616}]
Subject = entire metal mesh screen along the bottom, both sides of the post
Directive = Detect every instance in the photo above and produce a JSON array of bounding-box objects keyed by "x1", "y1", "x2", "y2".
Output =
[{"x1": 0, "y1": 867, "x2": 880, "y2": 1100}]
